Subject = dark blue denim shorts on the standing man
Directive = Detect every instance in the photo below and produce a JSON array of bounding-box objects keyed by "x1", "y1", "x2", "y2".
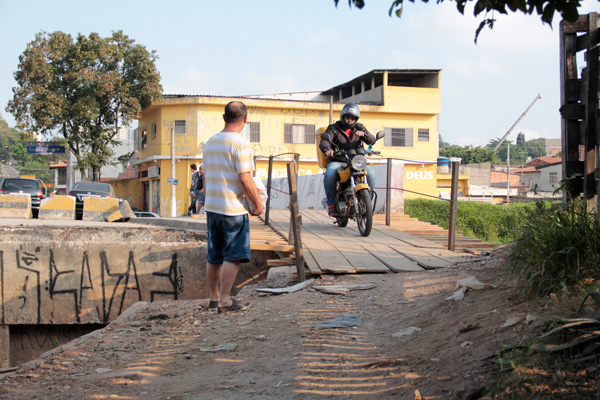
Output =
[{"x1": 206, "y1": 212, "x2": 250, "y2": 265}]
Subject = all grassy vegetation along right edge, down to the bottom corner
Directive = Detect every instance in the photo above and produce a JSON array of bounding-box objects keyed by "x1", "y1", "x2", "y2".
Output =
[{"x1": 488, "y1": 200, "x2": 600, "y2": 400}]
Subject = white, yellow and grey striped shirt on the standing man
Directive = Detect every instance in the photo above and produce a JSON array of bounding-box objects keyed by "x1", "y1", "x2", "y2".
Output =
[{"x1": 203, "y1": 132, "x2": 254, "y2": 215}]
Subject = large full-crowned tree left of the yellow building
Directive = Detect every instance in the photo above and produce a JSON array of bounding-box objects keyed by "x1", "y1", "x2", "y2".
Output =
[{"x1": 6, "y1": 31, "x2": 162, "y2": 180}]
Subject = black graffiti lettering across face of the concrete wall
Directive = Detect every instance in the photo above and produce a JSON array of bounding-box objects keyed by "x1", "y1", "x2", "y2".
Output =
[{"x1": 0, "y1": 244, "x2": 198, "y2": 324}]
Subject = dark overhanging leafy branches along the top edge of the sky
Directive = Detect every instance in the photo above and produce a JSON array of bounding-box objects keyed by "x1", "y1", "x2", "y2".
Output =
[{"x1": 333, "y1": 0, "x2": 581, "y2": 43}]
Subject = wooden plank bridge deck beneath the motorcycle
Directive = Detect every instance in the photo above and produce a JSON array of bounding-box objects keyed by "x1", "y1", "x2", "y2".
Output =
[{"x1": 250, "y1": 210, "x2": 497, "y2": 275}]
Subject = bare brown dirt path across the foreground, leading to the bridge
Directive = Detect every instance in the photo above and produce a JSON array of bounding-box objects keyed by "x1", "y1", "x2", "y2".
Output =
[{"x1": 0, "y1": 245, "x2": 547, "y2": 400}]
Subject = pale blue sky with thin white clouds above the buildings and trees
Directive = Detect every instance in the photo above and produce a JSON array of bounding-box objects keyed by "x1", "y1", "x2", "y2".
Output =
[{"x1": 0, "y1": 0, "x2": 600, "y2": 146}]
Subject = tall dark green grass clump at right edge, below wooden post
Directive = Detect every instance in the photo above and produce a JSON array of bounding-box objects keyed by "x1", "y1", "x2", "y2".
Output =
[{"x1": 509, "y1": 201, "x2": 600, "y2": 296}]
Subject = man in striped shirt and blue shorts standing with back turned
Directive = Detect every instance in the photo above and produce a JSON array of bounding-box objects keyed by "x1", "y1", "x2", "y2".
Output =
[{"x1": 204, "y1": 101, "x2": 264, "y2": 314}]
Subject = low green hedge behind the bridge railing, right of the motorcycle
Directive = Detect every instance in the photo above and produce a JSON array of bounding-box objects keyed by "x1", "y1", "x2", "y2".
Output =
[{"x1": 404, "y1": 199, "x2": 536, "y2": 243}]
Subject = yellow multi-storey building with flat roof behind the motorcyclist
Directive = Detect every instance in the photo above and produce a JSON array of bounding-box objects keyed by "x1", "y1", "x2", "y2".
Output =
[{"x1": 130, "y1": 70, "x2": 441, "y2": 216}]
